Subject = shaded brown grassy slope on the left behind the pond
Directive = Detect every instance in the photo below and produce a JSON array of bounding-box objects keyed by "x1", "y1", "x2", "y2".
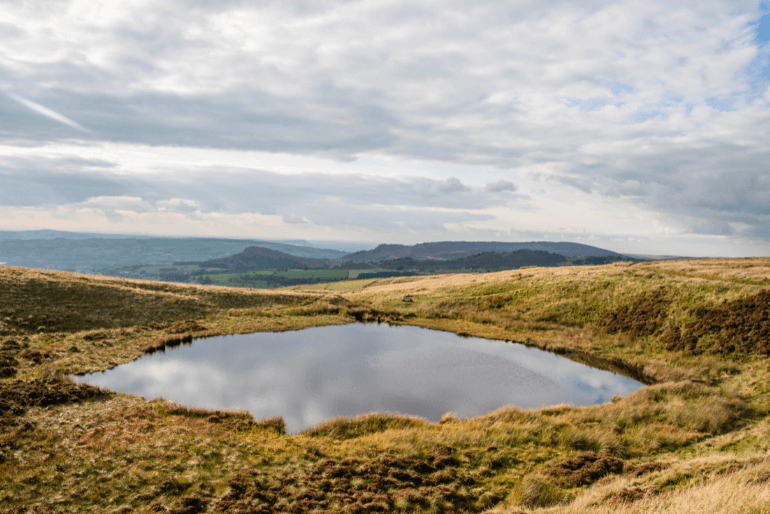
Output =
[{"x1": 0, "y1": 266, "x2": 318, "y2": 337}]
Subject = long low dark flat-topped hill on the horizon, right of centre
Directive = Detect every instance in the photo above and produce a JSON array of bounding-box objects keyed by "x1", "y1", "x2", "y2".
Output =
[{"x1": 340, "y1": 241, "x2": 621, "y2": 262}]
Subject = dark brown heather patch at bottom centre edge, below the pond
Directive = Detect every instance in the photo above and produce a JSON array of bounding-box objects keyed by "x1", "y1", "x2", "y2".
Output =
[{"x1": 215, "y1": 447, "x2": 486, "y2": 514}]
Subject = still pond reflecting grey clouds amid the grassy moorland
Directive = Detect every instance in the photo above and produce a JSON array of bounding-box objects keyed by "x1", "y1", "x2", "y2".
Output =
[{"x1": 74, "y1": 323, "x2": 643, "y2": 433}]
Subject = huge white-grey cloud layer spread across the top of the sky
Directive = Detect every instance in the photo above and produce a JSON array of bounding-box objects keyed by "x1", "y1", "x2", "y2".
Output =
[{"x1": 0, "y1": 1, "x2": 756, "y2": 159}]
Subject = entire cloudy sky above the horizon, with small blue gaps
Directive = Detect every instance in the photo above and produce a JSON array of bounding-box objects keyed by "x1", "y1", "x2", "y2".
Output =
[{"x1": 0, "y1": 0, "x2": 770, "y2": 256}]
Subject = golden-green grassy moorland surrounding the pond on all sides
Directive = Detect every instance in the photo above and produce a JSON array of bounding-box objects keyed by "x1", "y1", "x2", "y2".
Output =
[{"x1": 0, "y1": 259, "x2": 770, "y2": 514}]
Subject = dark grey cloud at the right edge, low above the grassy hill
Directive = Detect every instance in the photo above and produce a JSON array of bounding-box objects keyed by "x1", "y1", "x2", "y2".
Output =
[{"x1": 554, "y1": 141, "x2": 770, "y2": 238}]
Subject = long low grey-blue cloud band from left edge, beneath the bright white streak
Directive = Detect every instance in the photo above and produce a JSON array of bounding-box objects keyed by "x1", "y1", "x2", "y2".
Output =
[{"x1": 0, "y1": 153, "x2": 504, "y2": 234}]
